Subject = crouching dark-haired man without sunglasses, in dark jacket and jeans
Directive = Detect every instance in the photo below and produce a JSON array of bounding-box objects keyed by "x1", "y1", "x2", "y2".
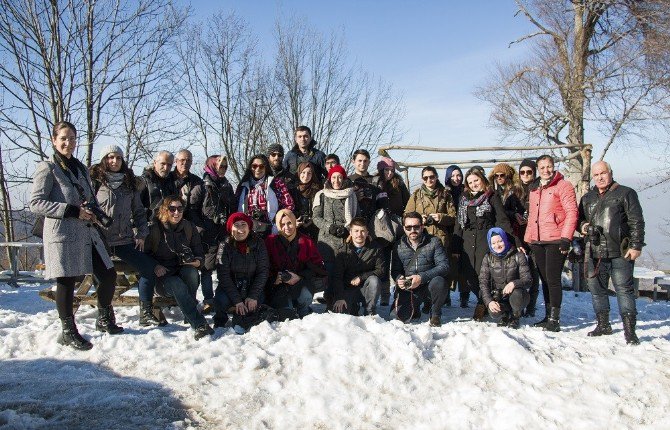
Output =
[{"x1": 333, "y1": 218, "x2": 388, "y2": 315}]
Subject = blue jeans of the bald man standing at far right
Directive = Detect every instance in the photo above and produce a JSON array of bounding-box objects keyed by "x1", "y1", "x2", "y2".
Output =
[{"x1": 587, "y1": 257, "x2": 637, "y2": 315}]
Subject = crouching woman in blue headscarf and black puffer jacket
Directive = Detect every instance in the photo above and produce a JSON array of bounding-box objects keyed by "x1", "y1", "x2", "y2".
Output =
[{"x1": 479, "y1": 227, "x2": 533, "y2": 328}]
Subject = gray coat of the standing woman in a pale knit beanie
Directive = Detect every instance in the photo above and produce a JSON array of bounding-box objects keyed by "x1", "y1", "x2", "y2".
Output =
[{"x1": 97, "y1": 184, "x2": 149, "y2": 246}]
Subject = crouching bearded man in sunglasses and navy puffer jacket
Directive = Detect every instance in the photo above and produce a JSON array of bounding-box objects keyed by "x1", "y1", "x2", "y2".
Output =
[{"x1": 391, "y1": 212, "x2": 449, "y2": 327}]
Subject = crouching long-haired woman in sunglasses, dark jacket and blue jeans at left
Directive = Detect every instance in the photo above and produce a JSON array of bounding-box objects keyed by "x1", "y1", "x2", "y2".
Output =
[{"x1": 139, "y1": 196, "x2": 214, "y2": 340}]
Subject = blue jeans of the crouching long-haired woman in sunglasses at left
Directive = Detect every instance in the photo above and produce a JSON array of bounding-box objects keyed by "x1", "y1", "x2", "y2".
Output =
[{"x1": 162, "y1": 266, "x2": 207, "y2": 329}]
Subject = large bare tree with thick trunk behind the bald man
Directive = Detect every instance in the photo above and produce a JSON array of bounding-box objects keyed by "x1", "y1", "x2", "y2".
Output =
[{"x1": 477, "y1": 0, "x2": 669, "y2": 194}]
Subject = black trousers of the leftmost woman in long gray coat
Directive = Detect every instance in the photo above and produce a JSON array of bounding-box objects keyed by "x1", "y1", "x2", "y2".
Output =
[{"x1": 56, "y1": 248, "x2": 116, "y2": 318}]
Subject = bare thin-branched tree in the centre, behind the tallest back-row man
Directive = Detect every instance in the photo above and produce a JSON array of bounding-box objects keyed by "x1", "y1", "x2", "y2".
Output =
[{"x1": 272, "y1": 20, "x2": 404, "y2": 170}]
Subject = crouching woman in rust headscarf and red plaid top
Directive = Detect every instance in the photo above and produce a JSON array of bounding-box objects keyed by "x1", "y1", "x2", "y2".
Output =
[{"x1": 265, "y1": 209, "x2": 327, "y2": 318}]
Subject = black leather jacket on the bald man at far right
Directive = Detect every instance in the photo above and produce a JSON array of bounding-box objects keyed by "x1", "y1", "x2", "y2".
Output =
[{"x1": 579, "y1": 182, "x2": 645, "y2": 258}]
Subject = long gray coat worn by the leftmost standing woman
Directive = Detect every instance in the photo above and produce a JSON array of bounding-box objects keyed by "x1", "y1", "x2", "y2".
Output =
[{"x1": 30, "y1": 161, "x2": 113, "y2": 279}]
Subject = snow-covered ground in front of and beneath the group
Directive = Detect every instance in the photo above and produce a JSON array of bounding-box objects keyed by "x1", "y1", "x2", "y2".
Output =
[{"x1": 0, "y1": 285, "x2": 670, "y2": 430}]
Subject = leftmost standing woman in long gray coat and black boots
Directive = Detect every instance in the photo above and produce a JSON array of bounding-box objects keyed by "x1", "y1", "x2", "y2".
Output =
[{"x1": 30, "y1": 121, "x2": 123, "y2": 350}]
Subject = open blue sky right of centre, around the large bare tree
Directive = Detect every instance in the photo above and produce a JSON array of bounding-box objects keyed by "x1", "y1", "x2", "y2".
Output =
[{"x1": 191, "y1": 0, "x2": 670, "y2": 262}]
